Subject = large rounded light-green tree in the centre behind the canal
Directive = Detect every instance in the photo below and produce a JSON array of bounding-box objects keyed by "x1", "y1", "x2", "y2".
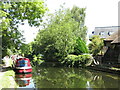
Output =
[{"x1": 33, "y1": 5, "x2": 86, "y2": 62}]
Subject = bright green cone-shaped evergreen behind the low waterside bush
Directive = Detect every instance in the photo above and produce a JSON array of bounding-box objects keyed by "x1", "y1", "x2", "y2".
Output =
[{"x1": 74, "y1": 38, "x2": 89, "y2": 55}]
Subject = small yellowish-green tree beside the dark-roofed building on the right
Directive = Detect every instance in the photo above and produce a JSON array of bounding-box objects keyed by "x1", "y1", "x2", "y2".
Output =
[{"x1": 88, "y1": 35, "x2": 104, "y2": 56}]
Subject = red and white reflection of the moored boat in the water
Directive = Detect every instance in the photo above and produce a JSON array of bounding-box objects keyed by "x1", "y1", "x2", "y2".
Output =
[{"x1": 15, "y1": 73, "x2": 35, "y2": 88}]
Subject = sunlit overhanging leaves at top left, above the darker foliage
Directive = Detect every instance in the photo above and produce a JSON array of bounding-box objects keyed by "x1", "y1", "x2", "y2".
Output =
[{"x1": 1, "y1": 0, "x2": 47, "y2": 26}]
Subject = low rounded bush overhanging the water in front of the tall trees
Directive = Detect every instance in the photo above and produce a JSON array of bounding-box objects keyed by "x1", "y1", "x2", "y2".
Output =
[{"x1": 62, "y1": 54, "x2": 93, "y2": 67}]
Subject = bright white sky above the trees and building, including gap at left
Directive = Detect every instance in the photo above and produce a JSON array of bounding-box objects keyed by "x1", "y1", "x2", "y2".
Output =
[{"x1": 20, "y1": 0, "x2": 120, "y2": 43}]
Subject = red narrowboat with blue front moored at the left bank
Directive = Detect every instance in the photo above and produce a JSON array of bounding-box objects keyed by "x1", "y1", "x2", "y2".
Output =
[{"x1": 15, "y1": 58, "x2": 32, "y2": 73}]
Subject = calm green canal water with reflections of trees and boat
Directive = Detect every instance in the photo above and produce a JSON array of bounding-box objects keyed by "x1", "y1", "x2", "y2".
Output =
[{"x1": 16, "y1": 67, "x2": 120, "y2": 88}]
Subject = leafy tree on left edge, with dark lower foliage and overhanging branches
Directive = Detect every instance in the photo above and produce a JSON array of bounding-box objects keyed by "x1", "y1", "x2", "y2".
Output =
[{"x1": 0, "y1": 0, "x2": 47, "y2": 56}]
